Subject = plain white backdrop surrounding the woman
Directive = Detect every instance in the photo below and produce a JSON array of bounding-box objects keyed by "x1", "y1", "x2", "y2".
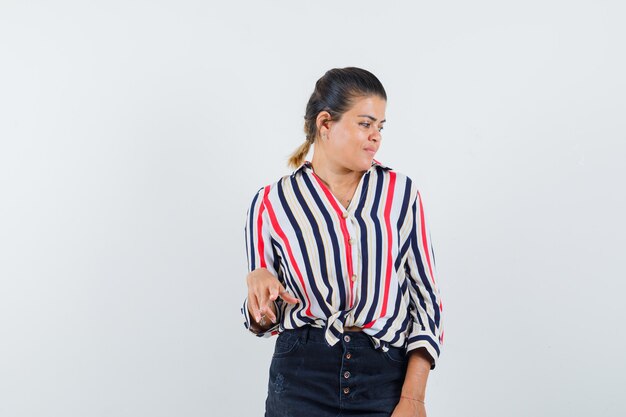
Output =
[{"x1": 0, "y1": 0, "x2": 626, "y2": 417}]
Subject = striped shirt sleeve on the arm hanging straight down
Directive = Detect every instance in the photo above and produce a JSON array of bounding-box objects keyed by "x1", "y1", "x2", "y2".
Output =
[{"x1": 405, "y1": 188, "x2": 443, "y2": 369}]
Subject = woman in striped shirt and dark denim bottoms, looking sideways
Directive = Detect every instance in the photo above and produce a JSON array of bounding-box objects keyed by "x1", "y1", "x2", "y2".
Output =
[{"x1": 242, "y1": 67, "x2": 443, "y2": 417}]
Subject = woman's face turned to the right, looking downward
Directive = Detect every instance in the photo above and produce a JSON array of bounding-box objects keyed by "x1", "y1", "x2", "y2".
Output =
[{"x1": 321, "y1": 96, "x2": 387, "y2": 171}]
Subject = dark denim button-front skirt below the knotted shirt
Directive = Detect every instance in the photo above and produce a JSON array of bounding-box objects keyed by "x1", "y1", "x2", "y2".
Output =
[{"x1": 265, "y1": 326, "x2": 407, "y2": 417}]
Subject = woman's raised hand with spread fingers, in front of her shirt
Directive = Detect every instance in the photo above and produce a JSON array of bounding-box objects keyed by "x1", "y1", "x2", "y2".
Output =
[{"x1": 246, "y1": 268, "x2": 300, "y2": 327}]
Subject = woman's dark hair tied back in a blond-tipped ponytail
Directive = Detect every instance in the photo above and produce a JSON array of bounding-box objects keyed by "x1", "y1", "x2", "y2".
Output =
[{"x1": 289, "y1": 67, "x2": 387, "y2": 168}]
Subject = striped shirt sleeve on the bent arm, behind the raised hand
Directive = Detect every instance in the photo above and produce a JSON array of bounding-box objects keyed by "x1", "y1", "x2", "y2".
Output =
[{"x1": 241, "y1": 186, "x2": 282, "y2": 337}]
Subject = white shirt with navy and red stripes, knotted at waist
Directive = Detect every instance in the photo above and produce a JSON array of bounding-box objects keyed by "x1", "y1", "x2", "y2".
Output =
[{"x1": 242, "y1": 161, "x2": 443, "y2": 369}]
